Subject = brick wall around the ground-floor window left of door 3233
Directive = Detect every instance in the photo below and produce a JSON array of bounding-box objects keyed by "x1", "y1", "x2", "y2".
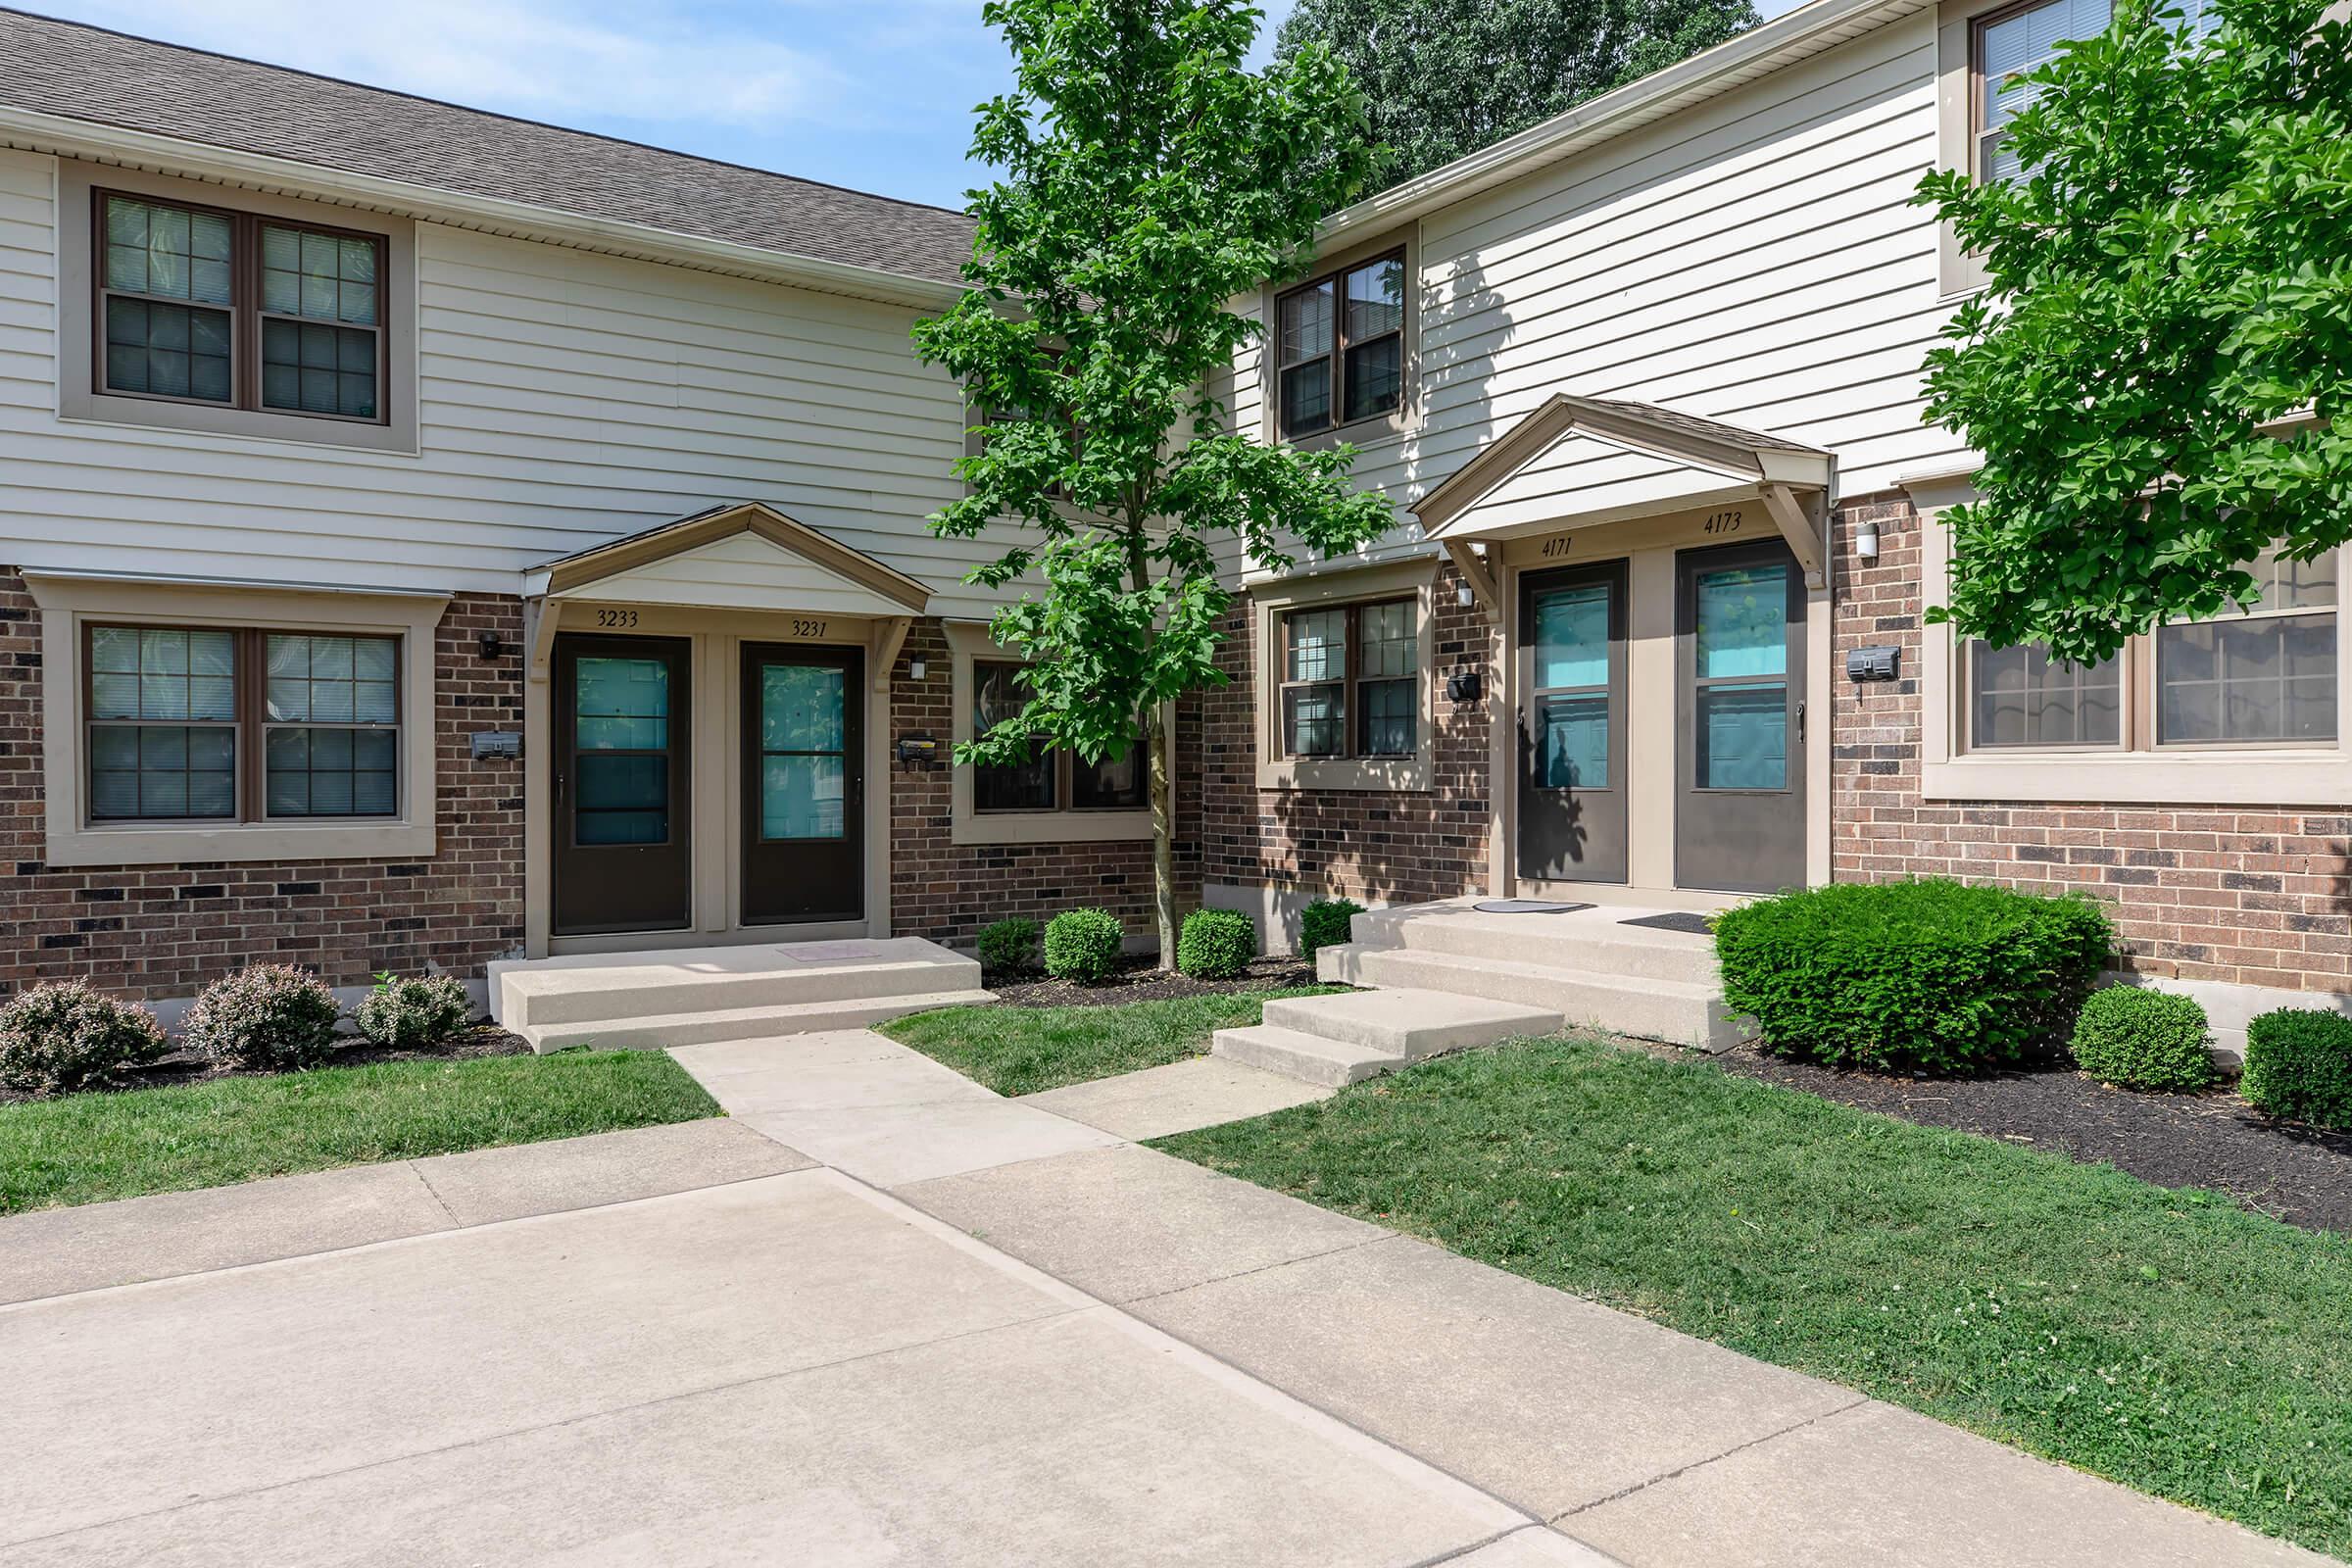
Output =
[{"x1": 0, "y1": 571, "x2": 522, "y2": 997}]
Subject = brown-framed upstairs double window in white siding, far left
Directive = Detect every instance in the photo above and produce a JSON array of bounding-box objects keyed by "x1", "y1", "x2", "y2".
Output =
[{"x1": 92, "y1": 190, "x2": 388, "y2": 423}]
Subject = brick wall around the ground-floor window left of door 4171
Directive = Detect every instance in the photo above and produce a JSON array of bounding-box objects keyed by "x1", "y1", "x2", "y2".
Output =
[{"x1": 1200, "y1": 566, "x2": 1500, "y2": 903}]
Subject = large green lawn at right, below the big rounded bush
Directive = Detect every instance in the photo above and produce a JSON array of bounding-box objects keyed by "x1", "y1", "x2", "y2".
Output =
[{"x1": 1157, "y1": 1039, "x2": 2352, "y2": 1556}]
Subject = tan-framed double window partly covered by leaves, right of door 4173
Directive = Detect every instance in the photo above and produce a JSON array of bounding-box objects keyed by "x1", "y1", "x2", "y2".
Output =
[{"x1": 1962, "y1": 550, "x2": 2338, "y2": 753}]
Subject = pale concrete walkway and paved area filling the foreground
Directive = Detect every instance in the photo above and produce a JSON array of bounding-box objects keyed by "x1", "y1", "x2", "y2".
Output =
[{"x1": 0, "y1": 1032, "x2": 2322, "y2": 1568}]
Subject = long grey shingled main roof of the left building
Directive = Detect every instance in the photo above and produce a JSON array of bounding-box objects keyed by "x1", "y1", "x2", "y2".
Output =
[{"x1": 0, "y1": 10, "x2": 971, "y2": 284}]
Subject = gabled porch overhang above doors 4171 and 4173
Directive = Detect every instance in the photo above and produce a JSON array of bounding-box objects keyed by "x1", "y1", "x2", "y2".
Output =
[{"x1": 1413, "y1": 393, "x2": 1837, "y2": 597}]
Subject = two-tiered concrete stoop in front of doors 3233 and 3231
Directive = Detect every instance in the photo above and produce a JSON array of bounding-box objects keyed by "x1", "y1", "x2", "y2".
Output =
[{"x1": 489, "y1": 936, "x2": 995, "y2": 1051}]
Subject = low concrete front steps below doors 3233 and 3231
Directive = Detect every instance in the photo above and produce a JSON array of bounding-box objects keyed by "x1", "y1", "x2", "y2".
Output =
[{"x1": 489, "y1": 936, "x2": 981, "y2": 1044}]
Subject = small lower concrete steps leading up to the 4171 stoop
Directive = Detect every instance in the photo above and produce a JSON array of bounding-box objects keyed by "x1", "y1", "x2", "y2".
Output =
[{"x1": 1211, "y1": 990, "x2": 1559, "y2": 1089}]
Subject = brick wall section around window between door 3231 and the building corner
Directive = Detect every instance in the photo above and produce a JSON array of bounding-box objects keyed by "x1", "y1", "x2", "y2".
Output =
[{"x1": 877, "y1": 620, "x2": 1200, "y2": 945}]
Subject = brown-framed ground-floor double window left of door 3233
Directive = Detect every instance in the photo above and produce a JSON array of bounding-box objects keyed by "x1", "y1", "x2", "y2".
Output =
[{"x1": 82, "y1": 625, "x2": 402, "y2": 823}]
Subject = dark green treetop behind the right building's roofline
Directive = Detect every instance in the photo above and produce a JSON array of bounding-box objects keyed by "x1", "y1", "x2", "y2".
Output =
[{"x1": 1275, "y1": 0, "x2": 1757, "y2": 188}]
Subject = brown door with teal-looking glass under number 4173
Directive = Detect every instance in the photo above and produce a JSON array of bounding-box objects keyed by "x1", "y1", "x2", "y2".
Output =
[{"x1": 1675, "y1": 541, "x2": 1806, "y2": 894}]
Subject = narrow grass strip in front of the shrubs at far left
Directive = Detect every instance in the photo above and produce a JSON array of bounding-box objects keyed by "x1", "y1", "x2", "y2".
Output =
[{"x1": 0, "y1": 1051, "x2": 719, "y2": 1213}]
